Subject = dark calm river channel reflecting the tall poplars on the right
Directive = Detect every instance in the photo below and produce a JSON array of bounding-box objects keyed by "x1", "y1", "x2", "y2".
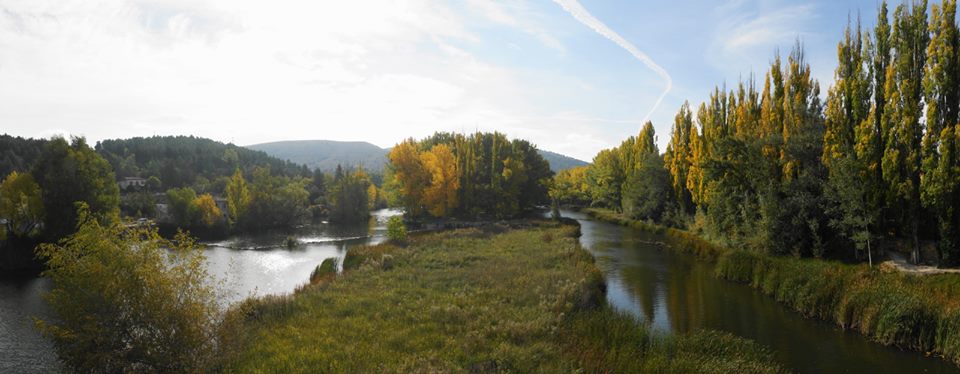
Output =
[{"x1": 563, "y1": 211, "x2": 960, "y2": 373}]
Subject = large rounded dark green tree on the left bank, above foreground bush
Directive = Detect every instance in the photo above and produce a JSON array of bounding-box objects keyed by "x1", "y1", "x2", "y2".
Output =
[{"x1": 31, "y1": 138, "x2": 120, "y2": 242}]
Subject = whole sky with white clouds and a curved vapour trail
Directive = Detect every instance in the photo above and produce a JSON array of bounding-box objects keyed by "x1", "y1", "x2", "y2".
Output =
[{"x1": 0, "y1": 0, "x2": 884, "y2": 161}]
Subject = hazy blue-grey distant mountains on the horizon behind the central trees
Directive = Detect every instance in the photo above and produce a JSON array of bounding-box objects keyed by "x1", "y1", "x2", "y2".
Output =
[{"x1": 246, "y1": 140, "x2": 587, "y2": 172}]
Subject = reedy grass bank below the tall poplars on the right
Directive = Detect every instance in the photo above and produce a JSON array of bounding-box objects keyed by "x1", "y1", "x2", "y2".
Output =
[{"x1": 586, "y1": 209, "x2": 960, "y2": 364}]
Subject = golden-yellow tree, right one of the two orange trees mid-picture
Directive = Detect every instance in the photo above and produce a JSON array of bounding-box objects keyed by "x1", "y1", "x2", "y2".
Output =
[{"x1": 421, "y1": 144, "x2": 460, "y2": 217}]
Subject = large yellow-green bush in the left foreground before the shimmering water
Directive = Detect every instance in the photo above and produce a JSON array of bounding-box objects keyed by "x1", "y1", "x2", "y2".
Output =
[{"x1": 37, "y1": 204, "x2": 223, "y2": 372}]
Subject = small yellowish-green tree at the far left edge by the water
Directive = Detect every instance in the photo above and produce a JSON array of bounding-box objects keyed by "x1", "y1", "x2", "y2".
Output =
[{"x1": 0, "y1": 171, "x2": 44, "y2": 237}]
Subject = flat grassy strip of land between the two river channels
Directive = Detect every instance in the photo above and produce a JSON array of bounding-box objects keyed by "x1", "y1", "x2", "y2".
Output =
[{"x1": 228, "y1": 222, "x2": 783, "y2": 373}]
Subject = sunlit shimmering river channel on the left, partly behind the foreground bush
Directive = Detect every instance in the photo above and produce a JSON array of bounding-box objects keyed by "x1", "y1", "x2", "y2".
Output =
[{"x1": 0, "y1": 210, "x2": 399, "y2": 373}]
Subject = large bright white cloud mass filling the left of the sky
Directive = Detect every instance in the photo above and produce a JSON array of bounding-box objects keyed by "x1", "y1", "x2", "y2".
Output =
[{"x1": 0, "y1": 0, "x2": 653, "y2": 160}]
